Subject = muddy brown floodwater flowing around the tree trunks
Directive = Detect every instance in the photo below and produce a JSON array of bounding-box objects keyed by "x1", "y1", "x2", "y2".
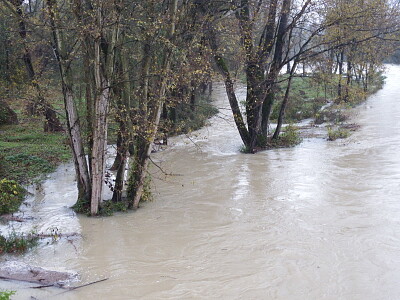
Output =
[{"x1": 0, "y1": 66, "x2": 400, "y2": 299}]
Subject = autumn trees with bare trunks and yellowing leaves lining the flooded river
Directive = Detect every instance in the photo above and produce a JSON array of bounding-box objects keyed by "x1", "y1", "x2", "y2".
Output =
[{"x1": 0, "y1": 0, "x2": 399, "y2": 215}]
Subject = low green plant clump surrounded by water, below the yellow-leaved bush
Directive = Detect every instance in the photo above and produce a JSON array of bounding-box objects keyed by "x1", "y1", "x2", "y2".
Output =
[{"x1": 0, "y1": 231, "x2": 38, "y2": 254}]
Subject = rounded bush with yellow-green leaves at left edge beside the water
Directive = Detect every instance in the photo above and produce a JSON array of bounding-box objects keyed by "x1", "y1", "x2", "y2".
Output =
[{"x1": 0, "y1": 178, "x2": 25, "y2": 215}]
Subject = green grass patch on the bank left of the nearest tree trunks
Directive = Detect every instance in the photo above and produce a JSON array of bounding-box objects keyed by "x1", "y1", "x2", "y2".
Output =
[{"x1": 0, "y1": 120, "x2": 71, "y2": 182}]
